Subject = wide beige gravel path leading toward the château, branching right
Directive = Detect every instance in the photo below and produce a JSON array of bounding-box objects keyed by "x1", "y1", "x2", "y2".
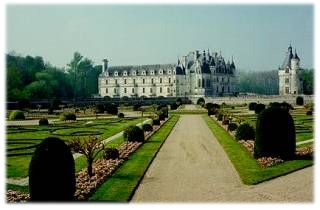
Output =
[{"x1": 132, "y1": 115, "x2": 313, "y2": 202}]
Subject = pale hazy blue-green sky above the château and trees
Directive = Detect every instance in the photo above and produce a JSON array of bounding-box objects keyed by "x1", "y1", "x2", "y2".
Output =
[{"x1": 6, "y1": 4, "x2": 314, "y2": 70}]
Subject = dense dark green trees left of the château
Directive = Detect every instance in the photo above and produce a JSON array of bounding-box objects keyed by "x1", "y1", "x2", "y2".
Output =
[{"x1": 6, "y1": 52, "x2": 102, "y2": 101}]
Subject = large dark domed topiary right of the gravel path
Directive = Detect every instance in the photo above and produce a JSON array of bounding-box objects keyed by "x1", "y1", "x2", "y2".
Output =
[{"x1": 254, "y1": 107, "x2": 296, "y2": 159}]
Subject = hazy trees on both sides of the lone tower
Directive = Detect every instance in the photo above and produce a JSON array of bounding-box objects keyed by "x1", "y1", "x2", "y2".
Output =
[{"x1": 238, "y1": 69, "x2": 314, "y2": 95}]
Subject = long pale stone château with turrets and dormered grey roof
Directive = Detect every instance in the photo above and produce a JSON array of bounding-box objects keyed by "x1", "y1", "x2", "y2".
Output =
[{"x1": 99, "y1": 51, "x2": 236, "y2": 97}]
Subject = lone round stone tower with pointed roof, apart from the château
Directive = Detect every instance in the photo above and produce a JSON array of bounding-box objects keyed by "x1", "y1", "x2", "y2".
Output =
[{"x1": 278, "y1": 45, "x2": 303, "y2": 95}]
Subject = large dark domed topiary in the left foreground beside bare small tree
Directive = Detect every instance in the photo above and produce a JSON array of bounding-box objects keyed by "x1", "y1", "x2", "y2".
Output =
[{"x1": 29, "y1": 137, "x2": 76, "y2": 201}]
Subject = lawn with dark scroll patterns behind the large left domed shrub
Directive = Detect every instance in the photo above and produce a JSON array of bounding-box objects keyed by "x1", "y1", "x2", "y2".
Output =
[{"x1": 6, "y1": 118, "x2": 146, "y2": 177}]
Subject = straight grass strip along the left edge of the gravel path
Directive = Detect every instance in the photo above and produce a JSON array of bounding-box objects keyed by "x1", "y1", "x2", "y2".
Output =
[{"x1": 90, "y1": 115, "x2": 179, "y2": 202}]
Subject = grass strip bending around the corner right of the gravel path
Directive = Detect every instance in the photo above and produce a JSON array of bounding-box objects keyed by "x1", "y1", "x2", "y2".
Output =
[{"x1": 204, "y1": 116, "x2": 313, "y2": 185}]
